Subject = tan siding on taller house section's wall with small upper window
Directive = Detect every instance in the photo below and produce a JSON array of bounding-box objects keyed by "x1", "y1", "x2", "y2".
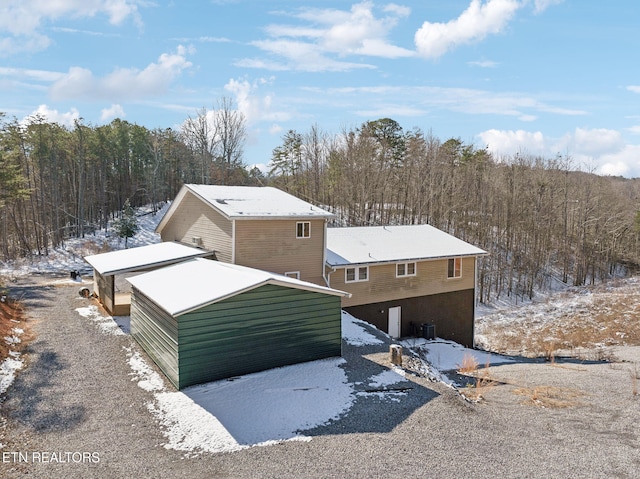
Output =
[{"x1": 235, "y1": 219, "x2": 326, "y2": 286}]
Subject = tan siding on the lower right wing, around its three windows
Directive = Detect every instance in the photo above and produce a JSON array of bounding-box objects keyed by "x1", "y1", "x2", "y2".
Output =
[{"x1": 329, "y1": 257, "x2": 475, "y2": 307}]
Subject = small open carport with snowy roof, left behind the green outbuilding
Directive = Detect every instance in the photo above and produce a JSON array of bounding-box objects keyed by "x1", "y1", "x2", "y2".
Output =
[{"x1": 84, "y1": 242, "x2": 212, "y2": 316}]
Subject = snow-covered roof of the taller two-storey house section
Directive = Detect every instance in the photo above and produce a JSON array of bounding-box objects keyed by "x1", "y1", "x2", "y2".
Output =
[{"x1": 185, "y1": 184, "x2": 333, "y2": 219}]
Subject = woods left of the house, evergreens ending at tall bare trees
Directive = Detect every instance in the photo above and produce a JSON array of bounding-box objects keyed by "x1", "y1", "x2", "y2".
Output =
[{"x1": 0, "y1": 99, "x2": 261, "y2": 260}]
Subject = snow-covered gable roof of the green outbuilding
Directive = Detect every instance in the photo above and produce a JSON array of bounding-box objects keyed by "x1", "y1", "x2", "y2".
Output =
[{"x1": 128, "y1": 258, "x2": 350, "y2": 316}]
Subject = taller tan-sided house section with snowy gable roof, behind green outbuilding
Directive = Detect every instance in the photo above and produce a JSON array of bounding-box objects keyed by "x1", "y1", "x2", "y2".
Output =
[{"x1": 156, "y1": 184, "x2": 333, "y2": 286}]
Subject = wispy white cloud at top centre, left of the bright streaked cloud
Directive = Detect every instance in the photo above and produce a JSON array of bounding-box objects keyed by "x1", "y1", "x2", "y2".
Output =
[{"x1": 240, "y1": 1, "x2": 413, "y2": 71}]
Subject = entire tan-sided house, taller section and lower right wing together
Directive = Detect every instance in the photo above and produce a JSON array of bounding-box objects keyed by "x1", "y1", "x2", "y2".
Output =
[{"x1": 156, "y1": 184, "x2": 487, "y2": 346}]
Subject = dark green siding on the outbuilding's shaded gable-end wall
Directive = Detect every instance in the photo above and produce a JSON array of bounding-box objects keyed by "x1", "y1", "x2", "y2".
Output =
[{"x1": 178, "y1": 285, "x2": 341, "y2": 388}]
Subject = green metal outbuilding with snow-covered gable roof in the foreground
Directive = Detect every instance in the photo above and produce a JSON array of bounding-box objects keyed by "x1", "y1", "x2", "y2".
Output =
[{"x1": 128, "y1": 259, "x2": 349, "y2": 389}]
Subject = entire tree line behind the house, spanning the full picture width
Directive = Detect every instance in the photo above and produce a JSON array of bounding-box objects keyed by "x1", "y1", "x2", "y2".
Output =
[{"x1": 0, "y1": 109, "x2": 640, "y2": 302}]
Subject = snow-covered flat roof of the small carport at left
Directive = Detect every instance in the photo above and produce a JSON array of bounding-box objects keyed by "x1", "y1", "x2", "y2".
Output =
[{"x1": 84, "y1": 242, "x2": 211, "y2": 275}]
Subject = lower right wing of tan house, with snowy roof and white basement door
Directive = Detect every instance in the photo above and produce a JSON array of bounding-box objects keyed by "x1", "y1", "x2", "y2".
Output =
[{"x1": 326, "y1": 225, "x2": 487, "y2": 346}]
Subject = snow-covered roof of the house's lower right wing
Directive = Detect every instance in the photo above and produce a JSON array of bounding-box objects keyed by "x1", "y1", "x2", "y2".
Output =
[{"x1": 327, "y1": 225, "x2": 487, "y2": 266}]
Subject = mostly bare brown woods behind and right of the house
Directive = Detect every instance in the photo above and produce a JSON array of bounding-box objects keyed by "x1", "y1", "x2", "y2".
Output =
[{"x1": 271, "y1": 118, "x2": 640, "y2": 302}]
